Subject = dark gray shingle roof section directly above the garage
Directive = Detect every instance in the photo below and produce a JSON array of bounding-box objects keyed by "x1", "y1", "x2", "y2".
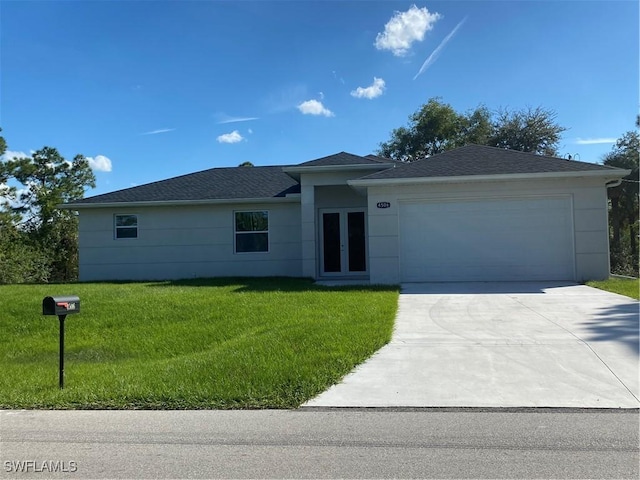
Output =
[{"x1": 363, "y1": 145, "x2": 618, "y2": 180}]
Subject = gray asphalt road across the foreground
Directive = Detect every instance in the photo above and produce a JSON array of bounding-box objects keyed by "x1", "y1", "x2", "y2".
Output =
[{"x1": 0, "y1": 409, "x2": 640, "y2": 479}]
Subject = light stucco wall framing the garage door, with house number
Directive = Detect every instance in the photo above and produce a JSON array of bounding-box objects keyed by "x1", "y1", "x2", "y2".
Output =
[{"x1": 368, "y1": 178, "x2": 609, "y2": 284}]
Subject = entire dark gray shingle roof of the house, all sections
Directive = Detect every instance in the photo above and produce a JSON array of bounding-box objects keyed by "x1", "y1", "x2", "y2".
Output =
[{"x1": 67, "y1": 145, "x2": 621, "y2": 206}]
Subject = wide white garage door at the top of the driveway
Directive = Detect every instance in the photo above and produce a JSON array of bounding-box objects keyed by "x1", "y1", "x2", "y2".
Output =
[{"x1": 400, "y1": 197, "x2": 575, "y2": 282}]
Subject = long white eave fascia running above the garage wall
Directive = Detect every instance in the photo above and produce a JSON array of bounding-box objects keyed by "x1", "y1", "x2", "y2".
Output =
[{"x1": 347, "y1": 169, "x2": 631, "y2": 187}]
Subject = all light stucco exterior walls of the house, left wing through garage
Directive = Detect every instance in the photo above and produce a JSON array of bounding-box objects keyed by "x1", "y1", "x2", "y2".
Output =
[{"x1": 79, "y1": 172, "x2": 609, "y2": 284}]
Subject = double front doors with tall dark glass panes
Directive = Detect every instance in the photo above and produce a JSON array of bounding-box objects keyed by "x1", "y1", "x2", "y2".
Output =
[{"x1": 319, "y1": 208, "x2": 367, "y2": 276}]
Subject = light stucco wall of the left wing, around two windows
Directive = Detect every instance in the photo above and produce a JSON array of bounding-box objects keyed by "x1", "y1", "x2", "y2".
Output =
[{"x1": 79, "y1": 203, "x2": 302, "y2": 281}]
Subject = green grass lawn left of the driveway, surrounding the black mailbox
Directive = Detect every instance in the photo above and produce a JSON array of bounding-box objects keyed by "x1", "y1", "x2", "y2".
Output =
[{"x1": 0, "y1": 278, "x2": 398, "y2": 409}]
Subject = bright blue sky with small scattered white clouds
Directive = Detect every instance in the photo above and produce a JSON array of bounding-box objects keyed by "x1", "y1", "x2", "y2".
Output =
[{"x1": 0, "y1": 0, "x2": 639, "y2": 195}]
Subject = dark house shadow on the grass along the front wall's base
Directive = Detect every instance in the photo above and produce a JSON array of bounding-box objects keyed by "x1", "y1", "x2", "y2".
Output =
[{"x1": 147, "y1": 277, "x2": 399, "y2": 292}]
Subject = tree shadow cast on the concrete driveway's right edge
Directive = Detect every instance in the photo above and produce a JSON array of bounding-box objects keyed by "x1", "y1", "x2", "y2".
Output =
[{"x1": 583, "y1": 302, "x2": 640, "y2": 355}]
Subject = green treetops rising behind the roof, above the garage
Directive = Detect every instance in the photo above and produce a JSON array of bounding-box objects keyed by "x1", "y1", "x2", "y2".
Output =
[{"x1": 377, "y1": 98, "x2": 566, "y2": 162}]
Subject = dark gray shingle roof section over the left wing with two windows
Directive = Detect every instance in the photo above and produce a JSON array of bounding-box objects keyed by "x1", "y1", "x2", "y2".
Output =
[{"x1": 66, "y1": 166, "x2": 300, "y2": 205}]
